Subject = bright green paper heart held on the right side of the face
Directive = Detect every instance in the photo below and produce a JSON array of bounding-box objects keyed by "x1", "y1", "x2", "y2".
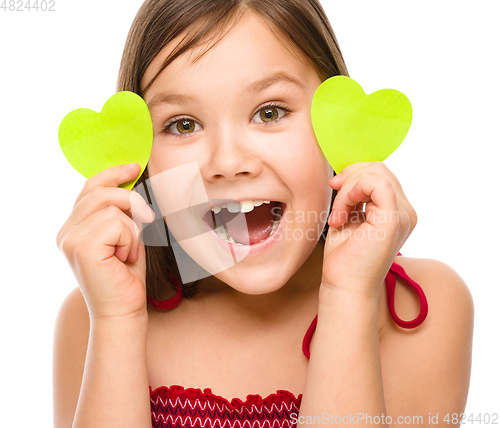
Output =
[{"x1": 311, "y1": 76, "x2": 412, "y2": 173}]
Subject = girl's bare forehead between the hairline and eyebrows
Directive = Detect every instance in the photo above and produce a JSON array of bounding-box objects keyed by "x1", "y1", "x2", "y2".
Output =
[{"x1": 141, "y1": 12, "x2": 318, "y2": 100}]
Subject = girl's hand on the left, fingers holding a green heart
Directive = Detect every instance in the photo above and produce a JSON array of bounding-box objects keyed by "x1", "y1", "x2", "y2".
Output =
[{"x1": 57, "y1": 163, "x2": 154, "y2": 319}]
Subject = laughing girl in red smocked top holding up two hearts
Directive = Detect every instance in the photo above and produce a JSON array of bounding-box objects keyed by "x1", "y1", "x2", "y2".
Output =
[{"x1": 54, "y1": 0, "x2": 473, "y2": 428}]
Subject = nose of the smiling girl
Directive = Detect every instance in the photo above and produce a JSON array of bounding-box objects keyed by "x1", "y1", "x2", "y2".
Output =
[{"x1": 204, "y1": 126, "x2": 262, "y2": 181}]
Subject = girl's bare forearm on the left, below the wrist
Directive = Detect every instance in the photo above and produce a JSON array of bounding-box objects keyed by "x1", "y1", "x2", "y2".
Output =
[{"x1": 72, "y1": 318, "x2": 151, "y2": 428}]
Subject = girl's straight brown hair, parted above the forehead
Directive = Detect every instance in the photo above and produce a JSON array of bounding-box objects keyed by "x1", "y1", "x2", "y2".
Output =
[{"x1": 117, "y1": 0, "x2": 348, "y2": 300}]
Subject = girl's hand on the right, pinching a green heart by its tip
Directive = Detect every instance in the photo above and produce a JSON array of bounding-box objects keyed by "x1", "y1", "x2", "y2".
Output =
[{"x1": 322, "y1": 162, "x2": 417, "y2": 298}]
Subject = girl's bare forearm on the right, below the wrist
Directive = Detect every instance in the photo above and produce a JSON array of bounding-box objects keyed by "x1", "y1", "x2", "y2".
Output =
[{"x1": 298, "y1": 286, "x2": 386, "y2": 427}]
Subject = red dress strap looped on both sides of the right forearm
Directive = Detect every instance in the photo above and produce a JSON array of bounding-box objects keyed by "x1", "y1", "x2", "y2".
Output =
[{"x1": 302, "y1": 253, "x2": 428, "y2": 359}]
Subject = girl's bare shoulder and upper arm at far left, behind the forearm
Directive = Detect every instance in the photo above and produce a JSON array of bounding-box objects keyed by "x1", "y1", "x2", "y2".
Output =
[{"x1": 52, "y1": 287, "x2": 90, "y2": 427}]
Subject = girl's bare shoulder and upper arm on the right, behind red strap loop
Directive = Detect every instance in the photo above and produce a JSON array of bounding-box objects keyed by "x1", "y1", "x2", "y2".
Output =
[{"x1": 380, "y1": 257, "x2": 474, "y2": 420}]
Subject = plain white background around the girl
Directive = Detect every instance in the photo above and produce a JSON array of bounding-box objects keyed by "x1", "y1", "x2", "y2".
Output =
[{"x1": 0, "y1": 0, "x2": 500, "y2": 426}]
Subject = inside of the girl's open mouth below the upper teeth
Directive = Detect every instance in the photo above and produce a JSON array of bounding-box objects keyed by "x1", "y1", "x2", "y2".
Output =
[{"x1": 220, "y1": 202, "x2": 281, "y2": 245}]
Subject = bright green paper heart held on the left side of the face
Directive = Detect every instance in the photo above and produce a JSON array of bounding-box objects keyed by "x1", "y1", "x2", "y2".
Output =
[{"x1": 59, "y1": 91, "x2": 153, "y2": 189}]
